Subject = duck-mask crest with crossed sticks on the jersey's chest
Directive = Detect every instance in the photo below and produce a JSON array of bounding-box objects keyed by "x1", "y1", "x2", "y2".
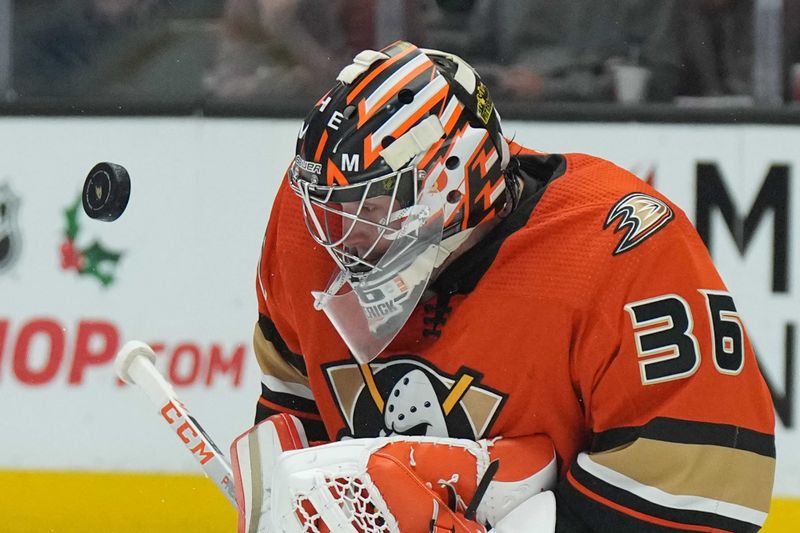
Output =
[{"x1": 323, "y1": 355, "x2": 507, "y2": 440}]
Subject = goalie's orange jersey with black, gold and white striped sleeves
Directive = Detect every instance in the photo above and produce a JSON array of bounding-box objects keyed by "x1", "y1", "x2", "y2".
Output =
[{"x1": 255, "y1": 148, "x2": 775, "y2": 532}]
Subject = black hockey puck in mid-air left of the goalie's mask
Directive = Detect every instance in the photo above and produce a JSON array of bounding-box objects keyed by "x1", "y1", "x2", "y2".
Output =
[{"x1": 83, "y1": 163, "x2": 131, "y2": 222}]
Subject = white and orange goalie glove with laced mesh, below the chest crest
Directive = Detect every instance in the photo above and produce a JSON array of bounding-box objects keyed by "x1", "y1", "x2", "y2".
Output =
[{"x1": 231, "y1": 414, "x2": 557, "y2": 533}]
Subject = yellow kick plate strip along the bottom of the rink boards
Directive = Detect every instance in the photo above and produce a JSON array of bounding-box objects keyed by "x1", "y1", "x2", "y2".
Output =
[{"x1": 0, "y1": 472, "x2": 800, "y2": 533}]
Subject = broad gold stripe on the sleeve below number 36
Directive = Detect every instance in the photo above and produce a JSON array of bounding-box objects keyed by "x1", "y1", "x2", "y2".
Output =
[{"x1": 591, "y1": 438, "x2": 775, "y2": 513}]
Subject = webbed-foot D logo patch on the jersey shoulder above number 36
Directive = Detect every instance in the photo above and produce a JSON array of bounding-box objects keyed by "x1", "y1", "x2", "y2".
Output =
[{"x1": 603, "y1": 192, "x2": 675, "y2": 255}]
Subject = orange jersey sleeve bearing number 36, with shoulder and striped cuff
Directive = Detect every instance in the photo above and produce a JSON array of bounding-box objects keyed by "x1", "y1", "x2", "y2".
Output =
[{"x1": 544, "y1": 153, "x2": 775, "y2": 531}]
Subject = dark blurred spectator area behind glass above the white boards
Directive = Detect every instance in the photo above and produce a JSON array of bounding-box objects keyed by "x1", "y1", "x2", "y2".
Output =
[{"x1": 0, "y1": 0, "x2": 800, "y2": 118}]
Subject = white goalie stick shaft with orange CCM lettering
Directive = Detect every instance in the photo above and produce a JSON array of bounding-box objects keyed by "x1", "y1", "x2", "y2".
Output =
[{"x1": 114, "y1": 341, "x2": 236, "y2": 507}]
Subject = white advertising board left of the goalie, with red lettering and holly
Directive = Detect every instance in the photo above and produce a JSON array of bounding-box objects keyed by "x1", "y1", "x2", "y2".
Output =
[{"x1": 0, "y1": 118, "x2": 296, "y2": 472}]
